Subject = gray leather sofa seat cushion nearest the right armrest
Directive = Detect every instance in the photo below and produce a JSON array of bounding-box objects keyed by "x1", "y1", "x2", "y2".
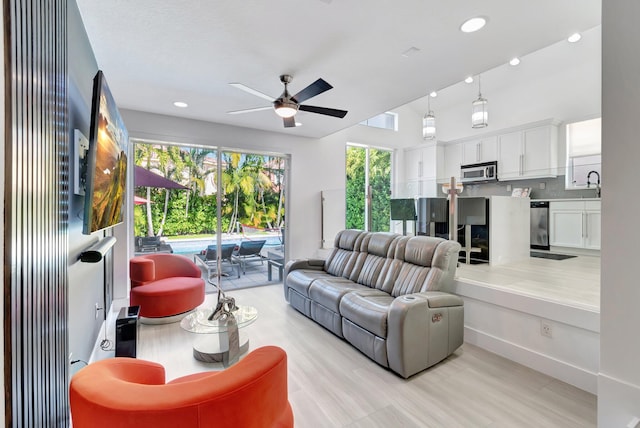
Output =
[{"x1": 340, "y1": 289, "x2": 394, "y2": 338}]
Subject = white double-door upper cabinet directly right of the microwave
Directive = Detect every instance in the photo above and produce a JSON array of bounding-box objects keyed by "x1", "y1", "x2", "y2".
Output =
[{"x1": 497, "y1": 123, "x2": 558, "y2": 180}]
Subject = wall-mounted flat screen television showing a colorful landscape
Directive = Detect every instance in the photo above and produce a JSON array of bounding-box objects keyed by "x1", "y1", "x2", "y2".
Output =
[{"x1": 82, "y1": 71, "x2": 129, "y2": 235}]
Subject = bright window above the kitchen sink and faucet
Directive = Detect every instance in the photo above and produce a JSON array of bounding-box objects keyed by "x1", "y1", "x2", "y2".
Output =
[{"x1": 565, "y1": 118, "x2": 602, "y2": 189}]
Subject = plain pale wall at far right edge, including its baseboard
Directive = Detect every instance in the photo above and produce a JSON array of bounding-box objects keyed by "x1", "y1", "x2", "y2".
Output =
[{"x1": 598, "y1": 0, "x2": 640, "y2": 427}]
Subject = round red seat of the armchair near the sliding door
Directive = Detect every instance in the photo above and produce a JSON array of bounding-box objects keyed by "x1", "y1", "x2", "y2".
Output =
[{"x1": 129, "y1": 276, "x2": 204, "y2": 318}]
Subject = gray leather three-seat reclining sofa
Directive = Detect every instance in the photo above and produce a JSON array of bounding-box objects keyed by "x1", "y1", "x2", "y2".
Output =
[{"x1": 284, "y1": 230, "x2": 464, "y2": 378}]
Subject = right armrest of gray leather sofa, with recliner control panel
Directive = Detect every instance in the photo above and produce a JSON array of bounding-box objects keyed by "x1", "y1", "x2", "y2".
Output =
[{"x1": 387, "y1": 291, "x2": 464, "y2": 378}]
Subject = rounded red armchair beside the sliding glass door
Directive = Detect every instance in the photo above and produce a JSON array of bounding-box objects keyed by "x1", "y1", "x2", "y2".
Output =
[{"x1": 129, "y1": 253, "x2": 204, "y2": 318}]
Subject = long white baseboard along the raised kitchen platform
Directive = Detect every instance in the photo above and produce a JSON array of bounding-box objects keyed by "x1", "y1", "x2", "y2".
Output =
[{"x1": 464, "y1": 326, "x2": 598, "y2": 394}]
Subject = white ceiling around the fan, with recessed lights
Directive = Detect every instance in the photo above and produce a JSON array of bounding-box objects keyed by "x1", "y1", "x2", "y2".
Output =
[{"x1": 77, "y1": 0, "x2": 601, "y2": 137}]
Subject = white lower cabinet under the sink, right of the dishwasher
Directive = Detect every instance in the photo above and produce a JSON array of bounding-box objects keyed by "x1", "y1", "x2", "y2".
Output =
[{"x1": 549, "y1": 200, "x2": 601, "y2": 250}]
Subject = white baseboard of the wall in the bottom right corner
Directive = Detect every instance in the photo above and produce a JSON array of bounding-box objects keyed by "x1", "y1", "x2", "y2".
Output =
[{"x1": 598, "y1": 373, "x2": 640, "y2": 428}]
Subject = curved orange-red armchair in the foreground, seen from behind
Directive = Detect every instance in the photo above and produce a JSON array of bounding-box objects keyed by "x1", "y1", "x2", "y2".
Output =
[{"x1": 69, "y1": 346, "x2": 293, "y2": 428}]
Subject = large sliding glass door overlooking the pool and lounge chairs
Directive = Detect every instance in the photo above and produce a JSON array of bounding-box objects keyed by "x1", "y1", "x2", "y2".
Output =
[{"x1": 134, "y1": 141, "x2": 288, "y2": 289}]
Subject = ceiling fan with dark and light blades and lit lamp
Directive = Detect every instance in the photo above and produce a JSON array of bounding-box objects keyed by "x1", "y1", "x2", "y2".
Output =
[{"x1": 227, "y1": 74, "x2": 347, "y2": 128}]
